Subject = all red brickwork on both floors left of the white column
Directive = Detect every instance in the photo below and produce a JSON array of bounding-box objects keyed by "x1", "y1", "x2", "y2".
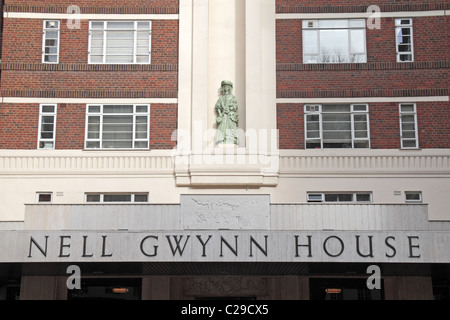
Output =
[{"x1": 0, "y1": 0, "x2": 178, "y2": 149}]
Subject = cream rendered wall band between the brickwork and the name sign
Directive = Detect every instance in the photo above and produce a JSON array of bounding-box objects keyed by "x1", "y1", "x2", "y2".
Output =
[{"x1": 0, "y1": 150, "x2": 450, "y2": 221}]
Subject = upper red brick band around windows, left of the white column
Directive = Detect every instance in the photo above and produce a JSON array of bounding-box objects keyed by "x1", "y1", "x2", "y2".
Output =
[{"x1": 1, "y1": 19, "x2": 178, "y2": 97}]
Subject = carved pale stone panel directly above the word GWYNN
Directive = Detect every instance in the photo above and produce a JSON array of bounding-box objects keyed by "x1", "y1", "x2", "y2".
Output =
[{"x1": 181, "y1": 195, "x2": 270, "y2": 230}]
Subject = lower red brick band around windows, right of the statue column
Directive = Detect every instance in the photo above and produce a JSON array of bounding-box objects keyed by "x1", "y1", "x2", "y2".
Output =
[{"x1": 277, "y1": 102, "x2": 450, "y2": 149}]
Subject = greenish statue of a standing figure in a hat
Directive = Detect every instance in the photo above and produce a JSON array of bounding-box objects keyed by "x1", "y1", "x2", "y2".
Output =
[{"x1": 216, "y1": 80, "x2": 238, "y2": 144}]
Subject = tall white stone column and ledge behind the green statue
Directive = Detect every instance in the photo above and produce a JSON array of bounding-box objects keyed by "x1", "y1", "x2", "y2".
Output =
[{"x1": 175, "y1": 0, "x2": 278, "y2": 186}]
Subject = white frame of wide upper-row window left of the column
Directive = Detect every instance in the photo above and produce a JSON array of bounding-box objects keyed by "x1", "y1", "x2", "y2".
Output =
[{"x1": 88, "y1": 20, "x2": 152, "y2": 64}]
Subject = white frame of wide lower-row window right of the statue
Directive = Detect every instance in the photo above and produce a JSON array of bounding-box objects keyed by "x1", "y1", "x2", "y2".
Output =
[{"x1": 304, "y1": 103, "x2": 370, "y2": 150}]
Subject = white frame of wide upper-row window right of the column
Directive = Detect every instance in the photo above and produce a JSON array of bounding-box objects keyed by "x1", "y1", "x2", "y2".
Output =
[{"x1": 302, "y1": 19, "x2": 367, "y2": 64}]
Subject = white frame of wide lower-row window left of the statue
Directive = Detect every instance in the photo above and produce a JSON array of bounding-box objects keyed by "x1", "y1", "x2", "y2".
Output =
[{"x1": 84, "y1": 103, "x2": 150, "y2": 150}]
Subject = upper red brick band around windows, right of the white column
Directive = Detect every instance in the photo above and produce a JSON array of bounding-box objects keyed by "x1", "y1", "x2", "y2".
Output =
[{"x1": 277, "y1": 17, "x2": 450, "y2": 97}]
